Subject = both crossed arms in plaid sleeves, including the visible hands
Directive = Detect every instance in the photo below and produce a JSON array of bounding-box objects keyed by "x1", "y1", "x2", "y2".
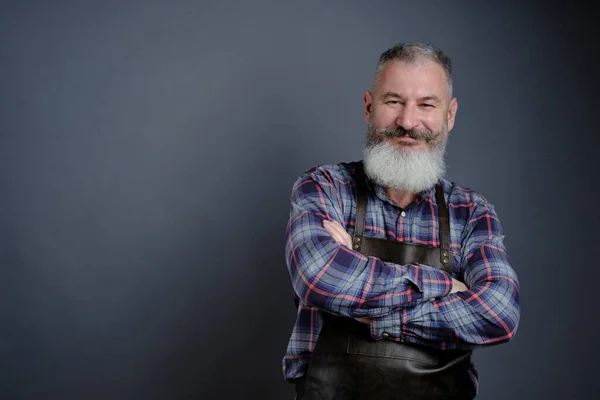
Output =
[{"x1": 286, "y1": 169, "x2": 519, "y2": 349}]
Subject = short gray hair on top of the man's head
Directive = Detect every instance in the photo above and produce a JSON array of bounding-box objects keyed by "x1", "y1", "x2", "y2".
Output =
[{"x1": 371, "y1": 42, "x2": 452, "y2": 98}]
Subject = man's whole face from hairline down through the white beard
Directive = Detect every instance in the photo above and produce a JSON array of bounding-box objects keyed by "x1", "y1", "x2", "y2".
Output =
[{"x1": 364, "y1": 61, "x2": 457, "y2": 193}]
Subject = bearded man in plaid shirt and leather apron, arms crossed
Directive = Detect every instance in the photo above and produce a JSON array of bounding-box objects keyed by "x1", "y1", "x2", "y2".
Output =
[{"x1": 283, "y1": 43, "x2": 520, "y2": 400}]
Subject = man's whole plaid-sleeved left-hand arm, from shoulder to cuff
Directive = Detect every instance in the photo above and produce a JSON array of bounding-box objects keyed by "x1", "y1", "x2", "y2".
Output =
[{"x1": 286, "y1": 169, "x2": 452, "y2": 317}]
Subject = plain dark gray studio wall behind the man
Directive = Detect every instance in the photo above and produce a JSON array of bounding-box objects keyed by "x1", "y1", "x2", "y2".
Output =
[{"x1": 0, "y1": 0, "x2": 600, "y2": 399}]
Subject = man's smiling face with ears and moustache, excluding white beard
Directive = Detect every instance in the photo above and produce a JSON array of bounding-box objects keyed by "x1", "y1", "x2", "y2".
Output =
[{"x1": 364, "y1": 61, "x2": 457, "y2": 152}]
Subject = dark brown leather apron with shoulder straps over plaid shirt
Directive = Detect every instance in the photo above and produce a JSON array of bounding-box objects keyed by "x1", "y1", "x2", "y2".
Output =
[{"x1": 295, "y1": 164, "x2": 475, "y2": 400}]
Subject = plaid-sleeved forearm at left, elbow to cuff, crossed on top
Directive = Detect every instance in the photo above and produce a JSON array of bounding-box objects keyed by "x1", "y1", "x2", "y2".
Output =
[{"x1": 286, "y1": 228, "x2": 452, "y2": 317}]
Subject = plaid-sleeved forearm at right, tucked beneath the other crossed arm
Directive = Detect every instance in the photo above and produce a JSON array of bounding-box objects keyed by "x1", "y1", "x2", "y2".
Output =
[{"x1": 371, "y1": 245, "x2": 520, "y2": 349}]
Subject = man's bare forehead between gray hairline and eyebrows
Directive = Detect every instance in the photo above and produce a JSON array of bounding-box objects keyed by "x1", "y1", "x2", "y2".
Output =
[{"x1": 374, "y1": 61, "x2": 448, "y2": 99}]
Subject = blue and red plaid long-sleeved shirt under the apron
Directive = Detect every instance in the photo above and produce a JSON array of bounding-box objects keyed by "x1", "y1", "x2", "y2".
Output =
[{"x1": 283, "y1": 163, "x2": 519, "y2": 390}]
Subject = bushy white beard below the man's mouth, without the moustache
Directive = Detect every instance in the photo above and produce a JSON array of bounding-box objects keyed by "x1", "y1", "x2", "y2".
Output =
[{"x1": 363, "y1": 134, "x2": 448, "y2": 193}]
